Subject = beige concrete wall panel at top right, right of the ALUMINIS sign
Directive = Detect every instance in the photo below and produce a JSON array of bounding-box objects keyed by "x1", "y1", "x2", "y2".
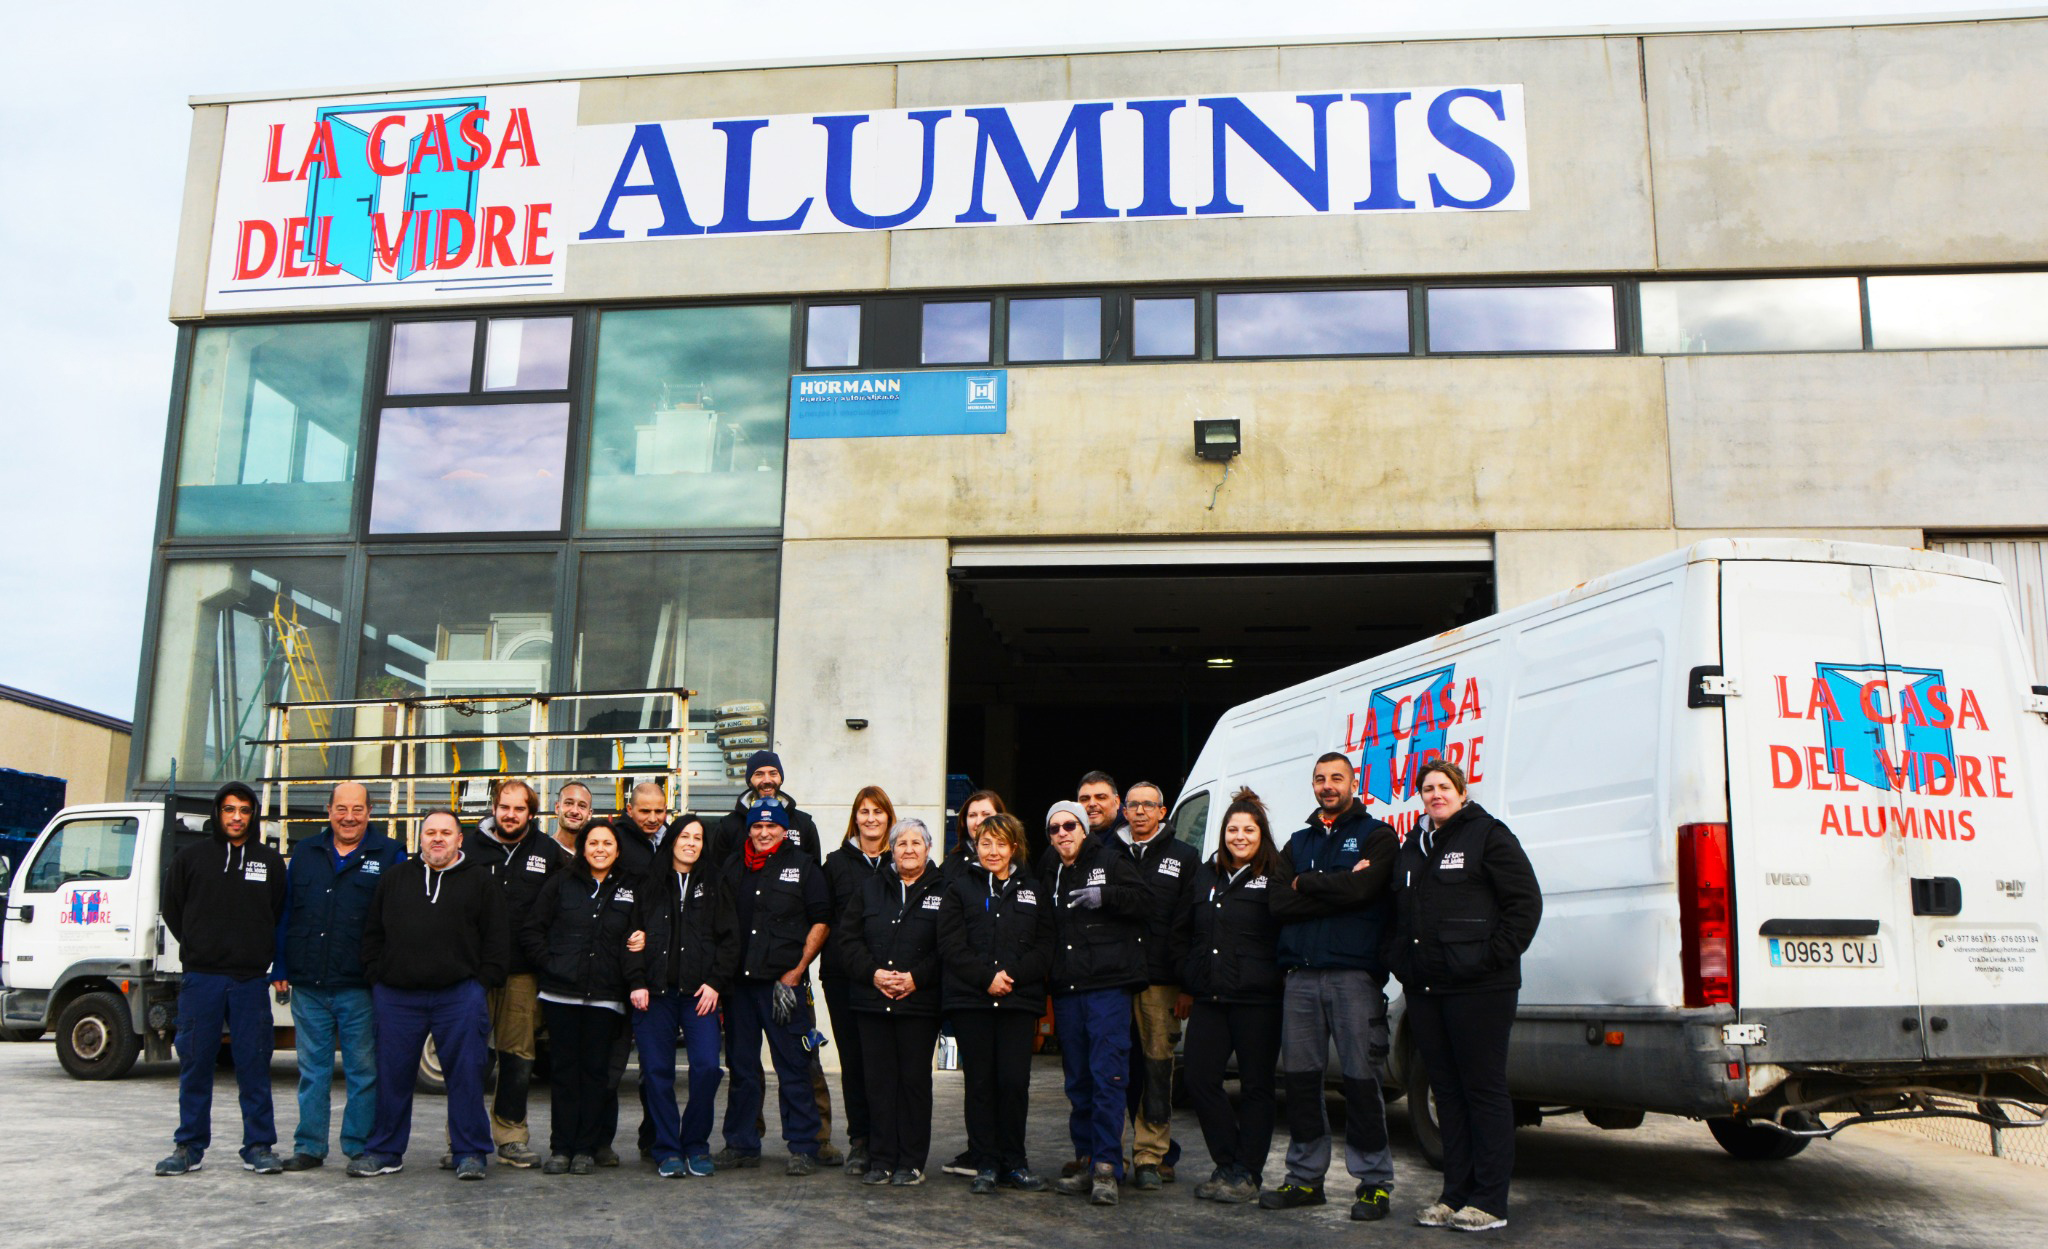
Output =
[{"x1": 1647, "y1": 20, "x2": 2048, "y2": 268}]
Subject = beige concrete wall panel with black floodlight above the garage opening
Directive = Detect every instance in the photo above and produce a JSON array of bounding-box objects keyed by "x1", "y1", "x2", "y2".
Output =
[{"x1": 784, "y1": 356, "x2": 1671, "y2": 540}]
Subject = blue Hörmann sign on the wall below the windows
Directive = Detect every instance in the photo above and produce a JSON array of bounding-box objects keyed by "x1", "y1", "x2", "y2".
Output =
[{"x1": 788, "y1": 369, "x2": 1010, "y2": 438}]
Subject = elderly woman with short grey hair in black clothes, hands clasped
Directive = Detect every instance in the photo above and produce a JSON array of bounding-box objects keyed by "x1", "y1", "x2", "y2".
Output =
[{"x1": 834, "y1": 819, "x2": 946, "y2": 1188}]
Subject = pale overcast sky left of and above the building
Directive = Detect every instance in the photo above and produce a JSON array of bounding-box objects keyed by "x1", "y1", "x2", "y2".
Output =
[{"x1": 0, "y1": 0, "x2": 2015, "y2": 720}]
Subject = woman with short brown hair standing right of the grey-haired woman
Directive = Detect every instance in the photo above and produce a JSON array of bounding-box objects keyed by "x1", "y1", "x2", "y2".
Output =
[{"x1": 938, "y1": 813, "x2": 1053, "y2": 1196}]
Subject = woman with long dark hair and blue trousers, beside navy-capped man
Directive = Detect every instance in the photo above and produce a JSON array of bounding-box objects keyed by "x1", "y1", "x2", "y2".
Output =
[{"x1": 625, "y1": 815, "x2": 739, "y2": 1179}]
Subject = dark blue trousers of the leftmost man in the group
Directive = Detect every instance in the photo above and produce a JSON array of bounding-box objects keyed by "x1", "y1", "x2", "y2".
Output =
[{"x1": 172, "y1": 971, "x2": 276, "y2": 1159}]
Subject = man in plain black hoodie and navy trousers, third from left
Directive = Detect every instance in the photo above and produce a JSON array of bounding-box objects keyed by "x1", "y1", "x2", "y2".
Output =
[{"x1": 348, "y1": 811, "x2": 507, "y2": 1179}]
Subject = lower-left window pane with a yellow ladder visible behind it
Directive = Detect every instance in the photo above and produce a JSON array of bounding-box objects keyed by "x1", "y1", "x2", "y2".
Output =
[{"x1": 141, "y1": 557, "x2": 348, "y2": 784}]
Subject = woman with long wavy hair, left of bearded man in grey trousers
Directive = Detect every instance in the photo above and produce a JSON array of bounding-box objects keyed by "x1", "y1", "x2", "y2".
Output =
[{"x1": 1176, "y1": 788, "x2": 1294, "y2": 1204}]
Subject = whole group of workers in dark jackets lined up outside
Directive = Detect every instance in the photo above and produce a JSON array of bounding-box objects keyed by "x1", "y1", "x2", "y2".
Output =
[{"x1": 158, "y1": 749, "x2": 1542, "y2": 1231}]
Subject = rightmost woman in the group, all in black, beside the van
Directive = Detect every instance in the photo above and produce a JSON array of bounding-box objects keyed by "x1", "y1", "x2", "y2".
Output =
[{"x1": 1386, "y1": 760, "x2": 1542, "y2": 1231}]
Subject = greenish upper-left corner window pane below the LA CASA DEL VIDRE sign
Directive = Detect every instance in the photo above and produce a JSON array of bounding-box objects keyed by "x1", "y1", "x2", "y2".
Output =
[{"x1": 172, "y1": 321, "x2": 371, "y2": 536}]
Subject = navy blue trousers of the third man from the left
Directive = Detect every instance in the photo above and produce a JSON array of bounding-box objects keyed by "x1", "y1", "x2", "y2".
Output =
[{"x1": 365, "y1": 981, "x2": 494, "y2": 1161}]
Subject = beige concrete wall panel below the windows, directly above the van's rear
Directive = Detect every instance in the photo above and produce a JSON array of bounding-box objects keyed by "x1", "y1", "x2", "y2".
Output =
[{"x1": 1663, "y1": 350, "x2": 2048, "y2": 528}]
